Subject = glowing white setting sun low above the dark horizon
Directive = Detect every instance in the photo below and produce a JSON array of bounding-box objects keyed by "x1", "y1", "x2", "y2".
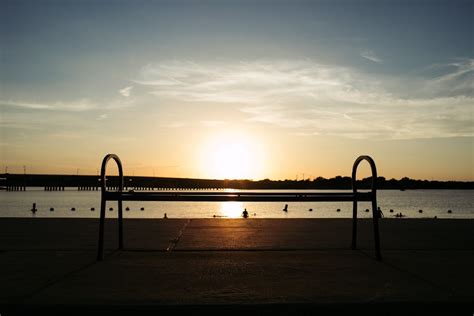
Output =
[{"x1": 204, "y1": 137, "x2": 262, "y2": 179}]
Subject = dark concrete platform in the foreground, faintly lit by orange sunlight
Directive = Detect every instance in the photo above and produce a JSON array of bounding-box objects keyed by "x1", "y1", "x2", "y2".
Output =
[{"x1": 0, "y1": 218, "x2": 474, "y2": 316}]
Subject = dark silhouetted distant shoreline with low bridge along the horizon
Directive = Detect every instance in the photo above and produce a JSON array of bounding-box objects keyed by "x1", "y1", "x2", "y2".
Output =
[{"x1": 0, "y1": 174, "x2": 474, "y2": 191}]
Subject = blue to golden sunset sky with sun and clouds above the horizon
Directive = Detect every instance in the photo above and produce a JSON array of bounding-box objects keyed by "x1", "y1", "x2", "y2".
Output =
[{"x1": 0, "y1": 0, "x2": 474, "y2": 181}]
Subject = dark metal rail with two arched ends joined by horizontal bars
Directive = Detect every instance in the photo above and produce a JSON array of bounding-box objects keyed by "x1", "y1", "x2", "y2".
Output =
[{"x1": 97, "y1": 154, "x2": 382, "y2": 261}]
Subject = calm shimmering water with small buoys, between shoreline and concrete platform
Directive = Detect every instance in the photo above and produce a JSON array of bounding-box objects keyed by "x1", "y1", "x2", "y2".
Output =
[{"x1": 0, "y1": 188, "x2": 474, "y2": 218}]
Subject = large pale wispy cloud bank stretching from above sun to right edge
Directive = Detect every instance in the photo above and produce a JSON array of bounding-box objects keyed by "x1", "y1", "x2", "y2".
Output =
[{"x1": 136, "y1": 59, "x2": 474, "y2": 139}]
